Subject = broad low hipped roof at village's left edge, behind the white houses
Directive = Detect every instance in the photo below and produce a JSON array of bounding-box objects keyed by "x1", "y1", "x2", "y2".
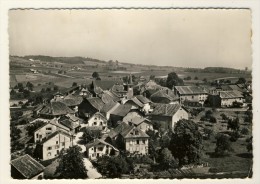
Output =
[{"x1": 39, "y1": 101, "x2": 74, "y2": 115}]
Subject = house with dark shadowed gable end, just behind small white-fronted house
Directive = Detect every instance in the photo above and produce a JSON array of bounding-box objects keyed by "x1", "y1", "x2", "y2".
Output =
[{"x1": 79, "y1": 97, "x2": 105, "y2": 118}]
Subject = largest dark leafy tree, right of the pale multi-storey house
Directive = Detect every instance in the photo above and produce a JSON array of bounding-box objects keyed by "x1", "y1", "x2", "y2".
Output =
[{"x1": 169, "y1": 119, "x2": 203, "y2": 166}]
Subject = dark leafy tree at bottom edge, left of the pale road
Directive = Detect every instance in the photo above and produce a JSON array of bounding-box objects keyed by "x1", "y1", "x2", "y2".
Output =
[{"x1": 55, "y1": 145, "x2": 88, "y2": 179}]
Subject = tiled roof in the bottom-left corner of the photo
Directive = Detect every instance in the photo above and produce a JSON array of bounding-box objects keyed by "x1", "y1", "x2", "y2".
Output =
[{"x1": 11, "y1": 154, "x2": 45, "y2": 179}]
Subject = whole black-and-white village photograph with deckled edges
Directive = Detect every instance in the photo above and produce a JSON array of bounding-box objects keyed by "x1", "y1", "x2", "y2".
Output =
[{"x1": 0, "y1": 0, "x2": 257, "y2": 181}]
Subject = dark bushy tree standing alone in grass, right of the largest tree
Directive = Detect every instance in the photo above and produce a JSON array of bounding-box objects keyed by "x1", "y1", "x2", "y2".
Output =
[{"x1": 215, "y1": 133, "x2": 233, "y2": 156}]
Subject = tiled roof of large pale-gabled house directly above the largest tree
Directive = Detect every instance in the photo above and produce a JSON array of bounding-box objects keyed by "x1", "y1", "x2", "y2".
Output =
[{"x1": 151, "y1": 103, "x2": 181, "y2": 116}]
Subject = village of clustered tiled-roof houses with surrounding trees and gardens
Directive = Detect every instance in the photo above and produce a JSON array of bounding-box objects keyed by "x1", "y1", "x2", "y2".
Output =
[{"x1": 10, "y1": 58, "x2": 252, "y2": 179}]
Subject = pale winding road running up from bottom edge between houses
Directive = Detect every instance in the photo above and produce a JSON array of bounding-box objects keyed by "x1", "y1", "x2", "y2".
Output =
[{"x1": 73, "y1": 132, "x2": 102, "y2": 179}]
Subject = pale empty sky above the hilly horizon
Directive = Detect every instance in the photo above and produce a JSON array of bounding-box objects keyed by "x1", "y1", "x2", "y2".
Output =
[{"x1": 8, "y1": 9, "x2": 252, "y2": 69}]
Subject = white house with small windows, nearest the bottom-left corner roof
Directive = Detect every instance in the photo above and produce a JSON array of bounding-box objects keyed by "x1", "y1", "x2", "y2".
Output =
[{"x1": 36, "y1": 130, "x2": 73, "y2": 160}]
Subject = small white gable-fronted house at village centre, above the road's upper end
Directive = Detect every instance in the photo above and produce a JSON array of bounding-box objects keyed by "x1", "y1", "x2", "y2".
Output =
[{"x1": 87, "y1": 112, "x2": 107, "y2": 130}]
